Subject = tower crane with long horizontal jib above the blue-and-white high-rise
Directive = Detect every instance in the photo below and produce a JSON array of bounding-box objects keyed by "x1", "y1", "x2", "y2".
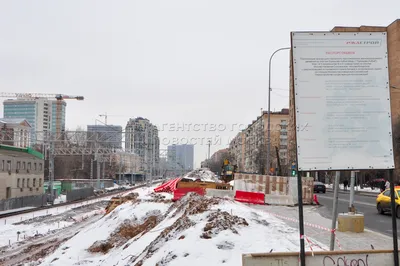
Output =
[{"x1": 0, "y1": 92, "x2": 84, "y2": 137}]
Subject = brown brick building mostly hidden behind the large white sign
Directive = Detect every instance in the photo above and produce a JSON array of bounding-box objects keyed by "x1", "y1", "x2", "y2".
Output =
[{"x1": 288, "y1": 19, "x2": 400, "y2": 177}]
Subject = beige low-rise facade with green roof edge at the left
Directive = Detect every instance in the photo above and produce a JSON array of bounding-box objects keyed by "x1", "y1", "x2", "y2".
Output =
[{"x1": 0, "y1": 145, "x2": 44, "y2": 200}]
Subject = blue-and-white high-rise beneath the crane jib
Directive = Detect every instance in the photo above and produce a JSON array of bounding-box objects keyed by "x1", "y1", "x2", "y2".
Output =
[{"x1": 3, "y1": 98, "x2": 67, "y2": 144}]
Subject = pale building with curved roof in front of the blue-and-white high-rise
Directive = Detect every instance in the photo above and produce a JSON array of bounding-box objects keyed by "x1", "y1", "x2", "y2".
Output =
[{"x1": 0, "y1": 118, "x2": 32, "y2": 148}]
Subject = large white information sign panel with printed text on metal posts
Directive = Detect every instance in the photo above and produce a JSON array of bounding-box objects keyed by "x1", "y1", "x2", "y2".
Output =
[{"x1": 292, "y1": 32, "x2": 394, "y2": 171}]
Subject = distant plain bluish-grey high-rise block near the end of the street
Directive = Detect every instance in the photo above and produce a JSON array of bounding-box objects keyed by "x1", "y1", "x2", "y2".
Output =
[{"x1": 167, "y1": 144, "x2": 194, "y2": 172}]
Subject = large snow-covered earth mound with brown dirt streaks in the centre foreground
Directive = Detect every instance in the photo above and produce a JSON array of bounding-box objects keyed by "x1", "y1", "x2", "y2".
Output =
[{"x1": 35, "y1": 189, "x2": 322, "y2": 266}]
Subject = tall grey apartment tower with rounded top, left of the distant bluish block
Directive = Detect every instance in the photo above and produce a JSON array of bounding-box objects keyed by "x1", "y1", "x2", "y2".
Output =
[{"x1": 125, "y1": 117, "x2": 160, "y2": 176}]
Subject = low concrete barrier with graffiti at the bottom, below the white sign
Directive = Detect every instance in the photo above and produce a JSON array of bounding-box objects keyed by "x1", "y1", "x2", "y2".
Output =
[{"x1": 242, "y1": 250, "x2": 393, "y2": 266}]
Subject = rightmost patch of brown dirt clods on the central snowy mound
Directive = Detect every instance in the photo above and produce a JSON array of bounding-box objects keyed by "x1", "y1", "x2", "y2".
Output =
[{"x1": 200, "y1": 210, "x2": 249, "y2": 239}]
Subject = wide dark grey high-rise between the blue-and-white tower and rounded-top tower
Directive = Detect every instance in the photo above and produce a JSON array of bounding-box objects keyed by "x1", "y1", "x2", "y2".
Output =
[{"x1": 87, "y1": 125, "x2": 122, "y2": 149}]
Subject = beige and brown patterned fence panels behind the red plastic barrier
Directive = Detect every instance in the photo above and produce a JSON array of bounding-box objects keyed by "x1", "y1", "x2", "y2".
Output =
[{"x1": 234, "y1": 173, "x2": 314, "y2": 205}]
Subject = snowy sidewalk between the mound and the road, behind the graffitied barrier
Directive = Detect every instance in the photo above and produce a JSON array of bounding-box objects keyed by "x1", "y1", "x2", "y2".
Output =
[{"x1": 249, "y1": 205, "x2": 393, "y2": 250}]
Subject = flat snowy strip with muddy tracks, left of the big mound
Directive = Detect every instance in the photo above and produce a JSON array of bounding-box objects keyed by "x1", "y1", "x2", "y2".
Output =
[{"x1": 0, "y1": 187, "x2": 166, "y2": 265}]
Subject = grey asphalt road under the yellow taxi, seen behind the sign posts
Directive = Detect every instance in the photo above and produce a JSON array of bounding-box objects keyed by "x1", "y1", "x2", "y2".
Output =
[{"x1": 317, "y1": 191, "x2": 400, "y2": 236}]
